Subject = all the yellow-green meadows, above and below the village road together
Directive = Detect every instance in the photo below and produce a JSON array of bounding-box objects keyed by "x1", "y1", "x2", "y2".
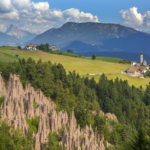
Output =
[{"x1": 0, "y1": 47, "x2": 150, "y2": 88}]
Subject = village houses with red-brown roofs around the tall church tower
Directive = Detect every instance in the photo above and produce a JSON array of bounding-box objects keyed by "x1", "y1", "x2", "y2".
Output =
[{"x1": 126, "y1": 51, "x2": 149, "y2": 75}]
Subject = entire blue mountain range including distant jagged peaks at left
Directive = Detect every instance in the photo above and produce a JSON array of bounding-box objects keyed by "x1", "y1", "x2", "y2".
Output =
[{"x1": 0, "y1": 22, "x2": 150, "y2": 59}]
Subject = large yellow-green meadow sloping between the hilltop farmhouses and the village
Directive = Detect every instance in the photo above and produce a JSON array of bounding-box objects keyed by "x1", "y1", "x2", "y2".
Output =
[{"x1": 0, "y1": 47, "x2": 129, "y2": 75}]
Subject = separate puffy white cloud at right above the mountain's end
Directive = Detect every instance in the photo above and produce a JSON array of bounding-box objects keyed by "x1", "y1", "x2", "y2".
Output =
[{"x1": 119, "y1": 7, "x2": 150, "y2": 29}]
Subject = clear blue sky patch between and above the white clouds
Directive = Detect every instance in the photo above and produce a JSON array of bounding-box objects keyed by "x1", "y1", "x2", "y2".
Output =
[{"x1": 34, "y1": 0, "x2": 150, "y2": 23}]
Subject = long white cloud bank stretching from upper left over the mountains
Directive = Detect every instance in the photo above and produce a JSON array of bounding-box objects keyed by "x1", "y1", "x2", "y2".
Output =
[{"x1": 0, "y1": 0, "x2": 98, "y2": 31}]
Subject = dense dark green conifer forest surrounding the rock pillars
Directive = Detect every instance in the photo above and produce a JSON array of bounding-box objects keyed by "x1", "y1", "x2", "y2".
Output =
[{"x1": 0, "y1": 58, "x2": 150, "y2": 150}]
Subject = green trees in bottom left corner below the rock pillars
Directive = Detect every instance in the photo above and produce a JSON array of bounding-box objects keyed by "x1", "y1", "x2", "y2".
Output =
[{"x1": 0, "y1": 120, "x2": 35, "y2": 150}]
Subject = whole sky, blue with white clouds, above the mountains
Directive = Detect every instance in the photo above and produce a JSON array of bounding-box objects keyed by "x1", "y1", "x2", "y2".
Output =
[{"x1": 0, "y1": 0, "x2": 150, "y2": 32}]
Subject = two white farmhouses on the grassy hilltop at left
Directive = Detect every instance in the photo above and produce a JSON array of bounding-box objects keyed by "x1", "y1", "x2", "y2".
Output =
[{"x1": 25, "y1": 43, "x2": 58, "y2": 51}]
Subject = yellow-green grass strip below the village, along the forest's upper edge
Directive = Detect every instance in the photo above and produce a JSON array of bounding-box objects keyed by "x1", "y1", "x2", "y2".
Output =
[{"x1": 88, "y1": 74, "x2": 150, "y2": 89}]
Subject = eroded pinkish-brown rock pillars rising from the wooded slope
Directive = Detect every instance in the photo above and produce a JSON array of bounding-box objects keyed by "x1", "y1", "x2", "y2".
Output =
[{"x1": 0, "y1": 74, "x2": 109, "y2": 150}]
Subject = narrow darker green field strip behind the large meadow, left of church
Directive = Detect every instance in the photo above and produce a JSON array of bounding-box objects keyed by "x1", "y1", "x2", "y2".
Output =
[{"x1": 86, "y1": 57, "x2": 125, "y2": 63}]
